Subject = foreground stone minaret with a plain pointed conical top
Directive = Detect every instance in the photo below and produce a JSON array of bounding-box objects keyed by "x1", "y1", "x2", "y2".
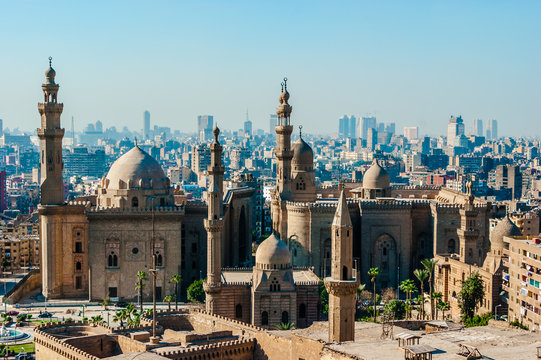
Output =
[{"x1": 325, "y1": 190, "x2": 359, "y2": 342}]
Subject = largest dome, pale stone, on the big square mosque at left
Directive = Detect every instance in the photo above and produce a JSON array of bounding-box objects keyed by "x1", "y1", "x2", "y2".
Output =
[{"x1": 106, "y1": 146, "x2": 169, "y2": 189}]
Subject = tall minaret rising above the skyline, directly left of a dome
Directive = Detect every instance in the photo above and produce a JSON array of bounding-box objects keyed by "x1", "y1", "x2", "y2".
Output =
[{"x1": 274, "y1": 78, "x2": 293, "y2": 200}]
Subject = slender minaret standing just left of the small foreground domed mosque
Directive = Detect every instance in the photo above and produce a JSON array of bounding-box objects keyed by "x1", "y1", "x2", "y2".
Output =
[{"x1": 204, "y1": 127, "x2": 224, "y2": 313}]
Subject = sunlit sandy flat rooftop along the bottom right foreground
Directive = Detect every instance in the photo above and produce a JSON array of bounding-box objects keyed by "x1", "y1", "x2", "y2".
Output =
[{"x1": 292, "y1": 322, "x2": 541, "y2": 360}]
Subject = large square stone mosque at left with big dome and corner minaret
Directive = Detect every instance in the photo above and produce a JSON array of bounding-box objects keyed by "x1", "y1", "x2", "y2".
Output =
[{"x1": 37, "y1": 61, "x2": 254, "y2": 300}]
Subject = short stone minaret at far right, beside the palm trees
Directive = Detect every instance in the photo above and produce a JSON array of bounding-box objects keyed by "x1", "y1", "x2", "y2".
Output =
[{"x1": 457, "y1": 181, "x2": 485, "y2": 266}]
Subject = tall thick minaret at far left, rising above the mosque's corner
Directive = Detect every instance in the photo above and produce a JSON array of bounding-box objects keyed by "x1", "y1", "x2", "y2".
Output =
[{"x1": 37, "y1": 57, "x2": 64, "y2": 205}]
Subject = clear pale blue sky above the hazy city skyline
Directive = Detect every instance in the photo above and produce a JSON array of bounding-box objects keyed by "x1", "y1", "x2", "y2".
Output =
[{"x1": 0, "y1": 0, "x2": 541, "y2": 137}]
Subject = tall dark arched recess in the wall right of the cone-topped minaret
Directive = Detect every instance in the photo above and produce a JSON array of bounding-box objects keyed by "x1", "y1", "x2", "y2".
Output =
[{"x1": 372, "y1": 234, "x2": 397, "y2": 289}]
